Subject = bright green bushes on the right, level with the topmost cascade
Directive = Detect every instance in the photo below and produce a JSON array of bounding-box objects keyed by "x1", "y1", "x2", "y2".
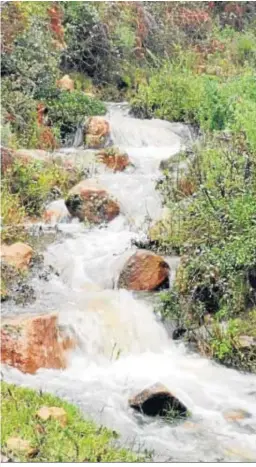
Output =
[{"x1": 132, "y1": 63, "x2": 256, "y2": 149}]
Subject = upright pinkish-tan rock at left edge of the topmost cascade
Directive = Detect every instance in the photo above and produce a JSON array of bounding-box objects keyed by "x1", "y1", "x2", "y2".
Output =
[{"x1": 85, "y1": 117, "x2": 110, "y2": 149}]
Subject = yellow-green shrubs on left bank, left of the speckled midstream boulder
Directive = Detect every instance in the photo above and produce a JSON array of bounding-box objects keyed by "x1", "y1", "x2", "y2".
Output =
[{"x1": 1, "y1": 158, "x2": 82, "y2": 242}]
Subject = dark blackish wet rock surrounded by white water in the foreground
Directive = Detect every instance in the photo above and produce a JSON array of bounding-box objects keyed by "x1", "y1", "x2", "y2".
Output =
[{"x1": 129, "y1": 383, "x2": 188, "y2": 418}]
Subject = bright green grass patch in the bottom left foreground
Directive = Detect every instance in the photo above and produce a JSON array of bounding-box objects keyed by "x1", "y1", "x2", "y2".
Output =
[{"x1": 1, "y1": 382, "x2": 143, "y2": 462}]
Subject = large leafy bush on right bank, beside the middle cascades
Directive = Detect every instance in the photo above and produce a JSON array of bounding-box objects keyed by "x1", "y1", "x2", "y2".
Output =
[{"x1": 156, "y1": 134, "x2": 256, "y2": 368}]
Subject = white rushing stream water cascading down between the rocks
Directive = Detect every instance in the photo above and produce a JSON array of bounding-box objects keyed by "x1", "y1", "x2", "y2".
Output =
[{"x1": 2, "y1": 104, "x2": 256, "y2": 461}]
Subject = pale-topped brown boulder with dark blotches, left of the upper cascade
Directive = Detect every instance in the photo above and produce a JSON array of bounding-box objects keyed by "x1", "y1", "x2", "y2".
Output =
[{"x1": 66, "y1": 179, "x2": 120, "y2": 224}]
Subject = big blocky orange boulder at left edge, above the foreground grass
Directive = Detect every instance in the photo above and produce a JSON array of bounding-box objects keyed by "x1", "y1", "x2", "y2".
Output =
[{"x1": 1, "y1": 314, "x2": 72, "y2": 373}]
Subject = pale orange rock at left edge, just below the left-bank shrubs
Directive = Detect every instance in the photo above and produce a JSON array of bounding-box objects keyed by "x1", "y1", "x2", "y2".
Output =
[{"x1": 1, "y1": 242, "x2": 33, "y2": 270}]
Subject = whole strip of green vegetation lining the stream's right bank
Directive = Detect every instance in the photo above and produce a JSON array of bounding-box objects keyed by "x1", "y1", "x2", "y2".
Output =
[{"x1": 150, "y1": 70, "x2": 256, "y2": 371}]
